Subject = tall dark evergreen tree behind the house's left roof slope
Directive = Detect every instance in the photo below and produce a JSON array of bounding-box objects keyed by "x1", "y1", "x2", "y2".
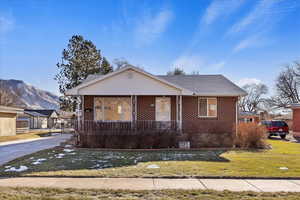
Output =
[{"x1": 55, "y1": 35, "x2": 113, "y2": 111}]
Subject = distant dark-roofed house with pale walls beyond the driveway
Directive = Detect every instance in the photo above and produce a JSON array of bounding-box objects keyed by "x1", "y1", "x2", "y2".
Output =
[{"x1": 25, "y1": 109, "x2": 58, "y2": 129}]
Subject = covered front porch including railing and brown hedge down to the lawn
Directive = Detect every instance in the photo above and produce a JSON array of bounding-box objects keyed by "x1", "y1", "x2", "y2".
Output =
[{"x1": 75, "y1": 95, "x2": 182, "y2": 148}]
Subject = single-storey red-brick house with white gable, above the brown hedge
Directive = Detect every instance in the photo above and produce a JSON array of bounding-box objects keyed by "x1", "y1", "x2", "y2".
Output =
[{"x1": 66, "y1": 67, "x2": 247, "y2": 146}]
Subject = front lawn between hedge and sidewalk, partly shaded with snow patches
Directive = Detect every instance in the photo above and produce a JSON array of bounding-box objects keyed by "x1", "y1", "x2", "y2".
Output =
[{"x1": 0, "y1": 140, "x2": 300, "y2": 177}]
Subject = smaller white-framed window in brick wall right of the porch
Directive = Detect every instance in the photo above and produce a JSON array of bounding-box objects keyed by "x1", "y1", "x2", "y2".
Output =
[{"x1": 198, "y1": 97, "x2": 217, "y2": 117}]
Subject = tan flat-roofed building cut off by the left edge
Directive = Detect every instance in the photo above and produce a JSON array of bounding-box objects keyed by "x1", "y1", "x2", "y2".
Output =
[{"x1": 0, "y1": 106, "x2": 23, "y2": 136}]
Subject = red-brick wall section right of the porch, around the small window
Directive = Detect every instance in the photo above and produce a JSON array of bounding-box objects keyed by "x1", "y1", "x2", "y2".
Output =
[{"x1": 182, "y1": 96, "x2": 237, "y2": 148}]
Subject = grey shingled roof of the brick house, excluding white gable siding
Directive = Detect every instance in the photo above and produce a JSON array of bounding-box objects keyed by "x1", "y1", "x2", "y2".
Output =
[{"x1": 66, "y1": 66, "x2": 247, "y2": 96}]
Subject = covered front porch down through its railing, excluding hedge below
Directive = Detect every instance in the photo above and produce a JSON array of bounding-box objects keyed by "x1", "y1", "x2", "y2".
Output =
[{"x1": 77, "y1": 95, "x2": 182, "y2": 133}]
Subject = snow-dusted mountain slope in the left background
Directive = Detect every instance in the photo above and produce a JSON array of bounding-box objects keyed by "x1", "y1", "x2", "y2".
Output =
[{"x1": 0, "y1": 79, "x2": 59, "y2": 109}]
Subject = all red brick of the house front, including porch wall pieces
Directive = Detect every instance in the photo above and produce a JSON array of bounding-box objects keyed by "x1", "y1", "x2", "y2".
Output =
[{"x1": 84, "y1": 96, "x2": 238, "y2": 148}]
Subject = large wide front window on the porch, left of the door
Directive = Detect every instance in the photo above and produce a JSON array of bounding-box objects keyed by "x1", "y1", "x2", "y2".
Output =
[{"x1": 94, "y1": 97, "x2": 132, "y2": 121}]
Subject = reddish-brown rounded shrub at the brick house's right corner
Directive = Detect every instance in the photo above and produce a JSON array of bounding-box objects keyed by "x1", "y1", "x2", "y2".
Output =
[{"x1": 234, "y1": 123, "x2": 268, "y2": 149}]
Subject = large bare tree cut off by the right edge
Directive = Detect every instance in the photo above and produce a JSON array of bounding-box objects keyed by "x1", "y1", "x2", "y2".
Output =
[{"x1": 267, "y1": 62, "x2": 300, "y2": 108}]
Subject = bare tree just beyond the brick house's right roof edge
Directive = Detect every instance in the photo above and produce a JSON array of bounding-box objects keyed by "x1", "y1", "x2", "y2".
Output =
[{"x1": 239, "y1": 83, "x2": 268, "y2": 112}]
